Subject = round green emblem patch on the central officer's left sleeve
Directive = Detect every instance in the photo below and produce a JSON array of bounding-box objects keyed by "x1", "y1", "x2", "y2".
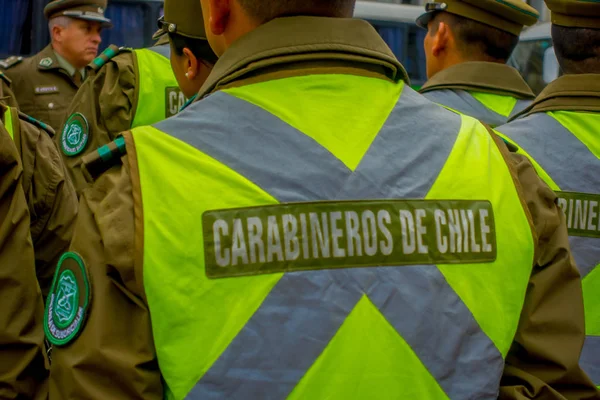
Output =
[{"x1": 44, "y1": 252, "x2": 91, "y2": 346}]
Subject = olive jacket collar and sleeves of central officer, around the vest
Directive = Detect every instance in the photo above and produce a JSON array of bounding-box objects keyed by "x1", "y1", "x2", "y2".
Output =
[{"x1": 50, "y1": 18, "x2": 598, "y2": 399}]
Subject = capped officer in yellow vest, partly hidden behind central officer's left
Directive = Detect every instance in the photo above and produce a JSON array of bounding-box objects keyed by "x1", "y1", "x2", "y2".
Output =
[{"x1": 55, "y1": 2, "x2": 216, "y2": 193}]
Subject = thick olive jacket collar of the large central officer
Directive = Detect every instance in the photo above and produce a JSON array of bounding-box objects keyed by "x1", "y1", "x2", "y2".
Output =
[{"x1": 197, "y1": 17, "x2": 408, "y2": 99}]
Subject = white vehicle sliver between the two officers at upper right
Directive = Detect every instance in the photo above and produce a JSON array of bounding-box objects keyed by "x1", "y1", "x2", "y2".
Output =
[{"x1": 508, "y1": 22, "x2": 561, "y2": 94}]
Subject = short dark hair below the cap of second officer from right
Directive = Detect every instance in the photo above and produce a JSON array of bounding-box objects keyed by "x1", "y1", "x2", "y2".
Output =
[{"x1": 432, "y1": 13, "x2": 519, "y2": 63}]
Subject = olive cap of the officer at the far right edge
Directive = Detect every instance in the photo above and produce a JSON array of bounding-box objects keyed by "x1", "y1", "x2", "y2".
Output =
[{"x1": 546, "y1": 0, "x2": 600, "y2": 29}]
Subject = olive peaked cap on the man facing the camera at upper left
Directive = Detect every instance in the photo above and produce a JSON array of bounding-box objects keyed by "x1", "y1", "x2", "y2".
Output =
[{"x1": 44, "y1": 0, "x2": 112, "y2": 28}]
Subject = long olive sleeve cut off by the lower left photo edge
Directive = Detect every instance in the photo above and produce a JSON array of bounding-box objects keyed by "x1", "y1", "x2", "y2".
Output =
[{"x1": 0, "y1": 123, "x2": 48, "y2": 399}]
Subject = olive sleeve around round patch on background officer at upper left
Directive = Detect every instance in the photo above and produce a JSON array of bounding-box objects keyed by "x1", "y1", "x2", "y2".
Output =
[{"x1": 55, "y1": 52, "x2": 137, "y2": 195}]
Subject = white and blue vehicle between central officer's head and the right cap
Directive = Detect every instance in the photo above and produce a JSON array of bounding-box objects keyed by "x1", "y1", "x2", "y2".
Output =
[{"x1": 354, "y1": 0, "x2": 427, "y2": 88}]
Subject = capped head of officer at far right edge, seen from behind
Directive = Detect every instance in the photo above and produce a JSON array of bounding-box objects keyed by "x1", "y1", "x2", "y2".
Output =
[{"x1": 546, "y1": 0, "x2": 600, "y2": 74}]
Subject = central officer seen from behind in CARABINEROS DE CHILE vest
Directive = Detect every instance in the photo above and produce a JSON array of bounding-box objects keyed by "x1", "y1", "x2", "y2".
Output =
[{"x1": 44, "y1": 0, "x2": 597, "y2": 400}]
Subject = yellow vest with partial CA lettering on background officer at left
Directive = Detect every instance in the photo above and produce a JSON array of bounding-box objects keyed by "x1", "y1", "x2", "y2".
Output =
[{"x1": 132, "y1": 45, "x2": 185, "y2": 128}]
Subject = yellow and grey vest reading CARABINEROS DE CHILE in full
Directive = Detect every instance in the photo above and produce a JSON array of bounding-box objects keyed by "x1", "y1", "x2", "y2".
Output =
[{"x1": 131, "y1": 74, "x2": 534, "y2": 399}]
